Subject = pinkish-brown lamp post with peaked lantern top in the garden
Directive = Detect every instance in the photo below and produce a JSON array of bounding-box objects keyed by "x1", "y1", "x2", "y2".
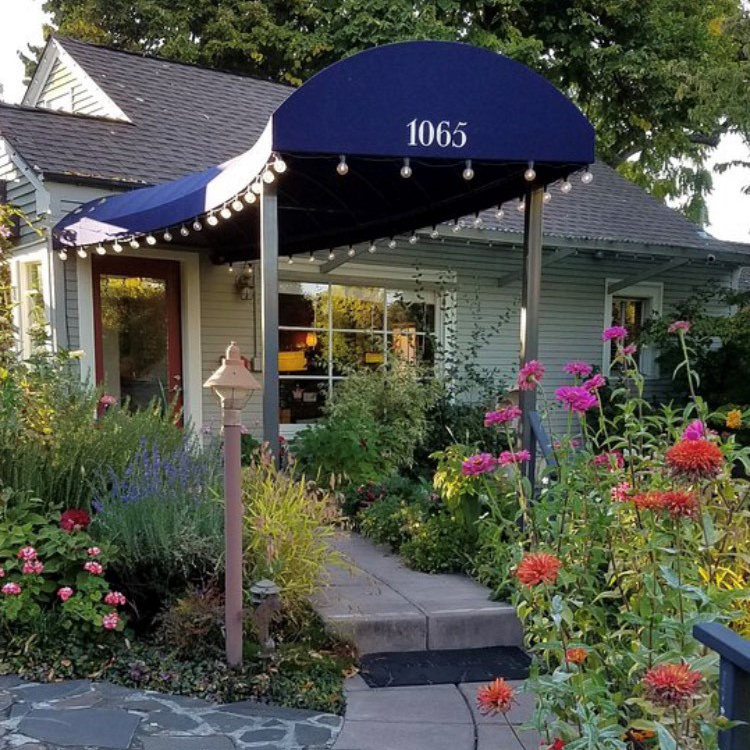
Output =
[{"x1": 203, "y1": 341, "x2": 260, "y2": 667}]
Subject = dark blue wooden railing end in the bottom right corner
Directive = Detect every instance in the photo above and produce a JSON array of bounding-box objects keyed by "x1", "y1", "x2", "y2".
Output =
[{"x1": 693, "y1": 622, "x2": 750, "y2": 750}]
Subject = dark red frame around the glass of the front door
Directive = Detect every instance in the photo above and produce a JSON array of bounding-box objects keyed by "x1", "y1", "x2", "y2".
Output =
[{"x1": 91, "y1": 255, "x2": 183, "y2": 414}]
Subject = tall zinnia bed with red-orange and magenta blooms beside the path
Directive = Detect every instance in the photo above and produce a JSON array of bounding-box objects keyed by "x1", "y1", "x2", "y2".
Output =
[{"x1": 472, "y1": 321, "x2": 750, "y2": 750}]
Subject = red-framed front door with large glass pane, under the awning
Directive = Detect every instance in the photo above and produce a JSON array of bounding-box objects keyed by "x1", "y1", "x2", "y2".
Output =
[{"x1": 92, "y1": 255, "x2": 182, "y2": 413}]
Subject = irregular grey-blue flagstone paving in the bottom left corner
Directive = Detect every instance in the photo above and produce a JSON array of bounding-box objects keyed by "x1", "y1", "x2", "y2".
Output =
[{"x1": 0, "y1": 677, "x2": 342, "y2": 750}]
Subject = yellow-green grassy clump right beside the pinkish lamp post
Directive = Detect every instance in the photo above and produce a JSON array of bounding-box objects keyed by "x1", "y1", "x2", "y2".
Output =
[{"x1": 243, "y1": 457, "x2": 340, "y2": 615}]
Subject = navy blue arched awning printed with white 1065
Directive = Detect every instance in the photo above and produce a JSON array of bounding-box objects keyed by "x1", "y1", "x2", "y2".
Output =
[{"x1": 53, "y1": 42, "x2": 594, "y2": 262}]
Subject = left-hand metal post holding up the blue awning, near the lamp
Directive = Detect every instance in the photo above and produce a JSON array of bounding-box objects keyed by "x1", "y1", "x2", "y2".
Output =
[{"x1": 260, "y1": 182, "x2": 279, "y2": 461}]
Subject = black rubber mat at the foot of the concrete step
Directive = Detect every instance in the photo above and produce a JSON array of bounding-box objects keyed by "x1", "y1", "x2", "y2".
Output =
[{"x1": 360, "y1": 646, "x2": 531, "y2": 687}]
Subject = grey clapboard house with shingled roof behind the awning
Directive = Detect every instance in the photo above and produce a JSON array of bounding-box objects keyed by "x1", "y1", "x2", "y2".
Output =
[{"x1": 0, "y1": 37, "x2": 750, "y2": 434}]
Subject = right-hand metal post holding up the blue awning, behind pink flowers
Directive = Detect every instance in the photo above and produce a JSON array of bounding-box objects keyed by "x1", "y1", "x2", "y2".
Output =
[{"x1": 519, "y1": 187, "x2": 544, "y2": 487}]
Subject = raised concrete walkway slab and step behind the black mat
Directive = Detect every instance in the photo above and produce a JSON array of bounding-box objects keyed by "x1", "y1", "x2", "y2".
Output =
[{"x1": 313, "y1": 533, "x2": 523, "y2": 654}]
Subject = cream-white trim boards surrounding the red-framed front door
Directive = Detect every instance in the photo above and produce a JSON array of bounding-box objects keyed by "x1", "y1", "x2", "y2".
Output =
[{"x1": 76, "y1": 249, "x2": 203, "y2": 431}]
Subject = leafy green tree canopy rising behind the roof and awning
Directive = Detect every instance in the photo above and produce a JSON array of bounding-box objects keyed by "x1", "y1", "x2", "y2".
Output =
[{"x1": 32, "y1": 0, "x2": 750, "y2": 218}]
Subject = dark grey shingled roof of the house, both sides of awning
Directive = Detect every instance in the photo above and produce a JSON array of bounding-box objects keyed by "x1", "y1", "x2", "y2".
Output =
[{"x1": 0, "y1": 37, "x2": 750, "y2": 253}]
